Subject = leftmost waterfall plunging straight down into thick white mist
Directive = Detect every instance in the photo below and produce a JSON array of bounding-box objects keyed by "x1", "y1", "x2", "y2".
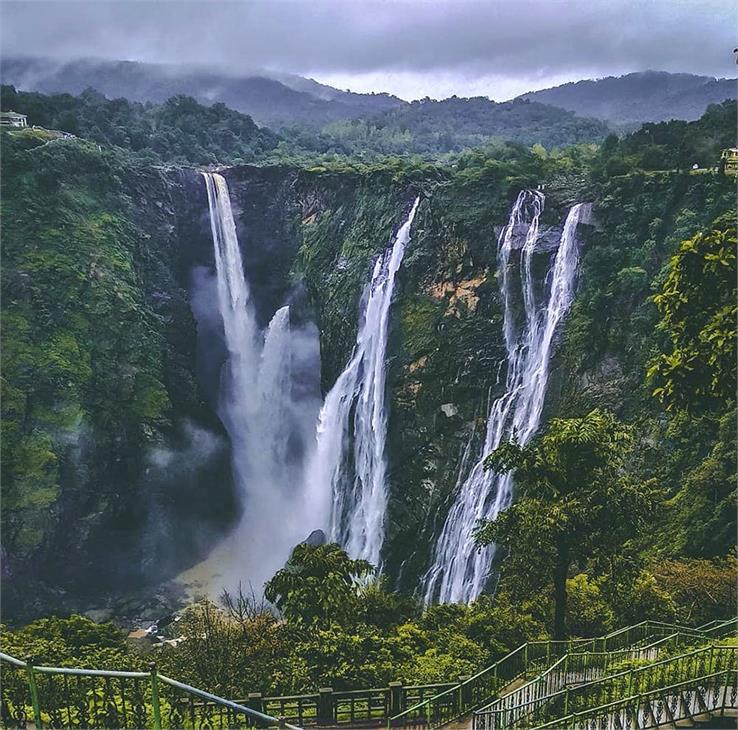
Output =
[{"x1": 194, "y1": 173, "x2": 317, "y2": 591}]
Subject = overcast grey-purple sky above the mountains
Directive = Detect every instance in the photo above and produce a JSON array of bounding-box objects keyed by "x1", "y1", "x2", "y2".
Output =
[{"x1": 0, "y1": 0, "x2": 738, "y2": 100}]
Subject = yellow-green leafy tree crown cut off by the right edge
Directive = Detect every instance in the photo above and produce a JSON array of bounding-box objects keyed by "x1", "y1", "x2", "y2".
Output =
[{"x1": 648, "y1": 214, "x2": 738, "y2": 411}]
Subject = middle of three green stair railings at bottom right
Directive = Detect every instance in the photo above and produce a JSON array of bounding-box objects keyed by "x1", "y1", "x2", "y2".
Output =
[{"x1": 473, "y1": 642, "x2": 738, "y2": 730}]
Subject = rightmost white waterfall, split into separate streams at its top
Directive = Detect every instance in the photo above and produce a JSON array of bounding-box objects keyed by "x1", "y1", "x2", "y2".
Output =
[{"x1": 424, "y1": 190, "x2": 589, "y2": 603}]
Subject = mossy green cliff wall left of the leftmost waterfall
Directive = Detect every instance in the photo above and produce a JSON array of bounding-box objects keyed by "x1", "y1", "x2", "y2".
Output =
[{"x1": 3, "y1": 144, "x2": 234, "y2": 618}]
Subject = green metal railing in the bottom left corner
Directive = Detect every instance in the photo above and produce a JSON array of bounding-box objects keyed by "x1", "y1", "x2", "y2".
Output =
[{"x1": 0, "y1": 653, "x2": 299, "y2": 730}]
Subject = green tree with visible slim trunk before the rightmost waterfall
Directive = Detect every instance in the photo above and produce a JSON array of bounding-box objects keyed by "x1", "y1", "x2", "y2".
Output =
[{"x1": 477, "y1": 409, "x2": 654, "y2": 639}]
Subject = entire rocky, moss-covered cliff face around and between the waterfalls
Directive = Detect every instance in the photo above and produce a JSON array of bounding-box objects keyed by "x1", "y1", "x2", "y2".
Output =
[{"x1": 3, "y1": 132, "x2": 730, "y2": 618}]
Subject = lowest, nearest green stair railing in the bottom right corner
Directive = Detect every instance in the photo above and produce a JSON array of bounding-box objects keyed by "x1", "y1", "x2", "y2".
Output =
[{"x1": 535, "y1": 669, "x2": 738, "y2": 730}]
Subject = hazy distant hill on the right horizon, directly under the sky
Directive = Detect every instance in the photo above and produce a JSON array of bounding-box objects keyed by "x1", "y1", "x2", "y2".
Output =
[{"x1": 520, "y1": 71, "x2": 736, "y2": 124}]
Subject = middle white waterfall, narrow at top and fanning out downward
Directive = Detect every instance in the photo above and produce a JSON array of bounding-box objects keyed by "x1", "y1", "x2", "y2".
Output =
[{"x1": 309, "y1": 198, "x2": 420, "y2": 565}]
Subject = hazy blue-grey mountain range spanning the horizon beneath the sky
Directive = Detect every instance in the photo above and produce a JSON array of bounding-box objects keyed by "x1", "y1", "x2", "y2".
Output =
[{"x1": 0, "y1": 57, "x2": 736, "y2": 156}]
